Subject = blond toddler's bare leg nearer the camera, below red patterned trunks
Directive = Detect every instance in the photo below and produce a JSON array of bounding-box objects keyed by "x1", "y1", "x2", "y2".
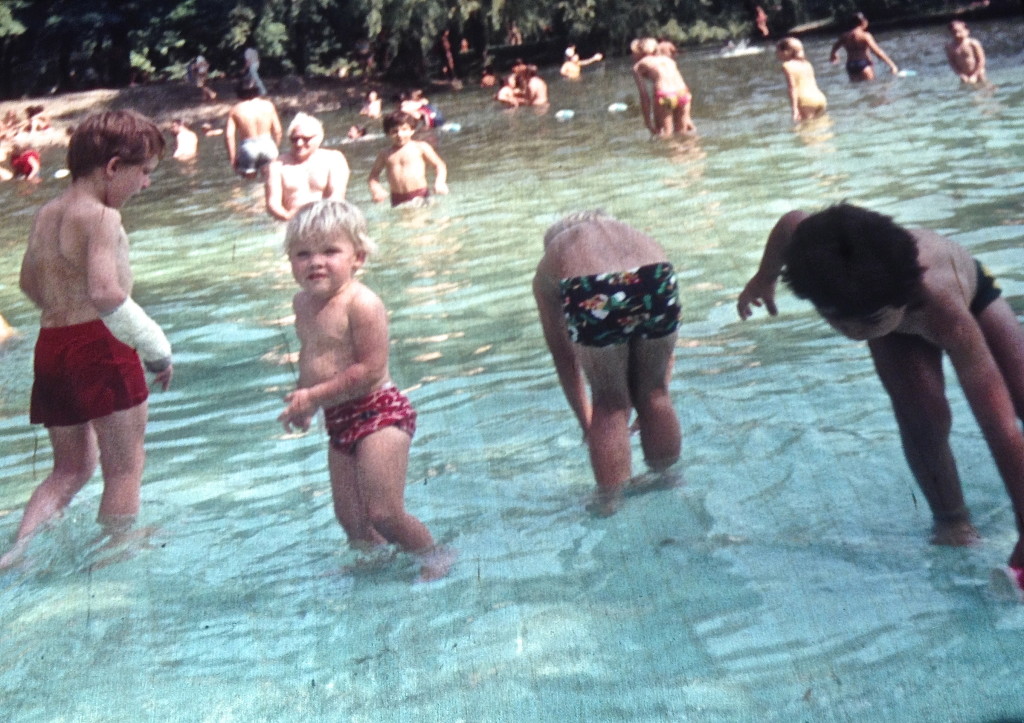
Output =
[{"x1": 355, "y1": 427, "x2": 434, "y2": 553}]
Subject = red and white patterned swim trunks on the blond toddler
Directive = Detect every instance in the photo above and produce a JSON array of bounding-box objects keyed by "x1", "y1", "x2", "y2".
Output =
[{"x1": 324, "y1": 384, "x2": 416, "y2": 455}]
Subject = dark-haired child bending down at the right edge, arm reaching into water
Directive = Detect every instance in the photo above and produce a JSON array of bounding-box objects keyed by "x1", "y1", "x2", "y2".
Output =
[{"x1": 737, "y1": 204, "x2": 1024, "y2": 591}]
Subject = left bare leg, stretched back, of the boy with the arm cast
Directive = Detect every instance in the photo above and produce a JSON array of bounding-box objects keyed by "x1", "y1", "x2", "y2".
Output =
[{"x1": 0, "y1": 424, "x2": 99, "y2": 567}]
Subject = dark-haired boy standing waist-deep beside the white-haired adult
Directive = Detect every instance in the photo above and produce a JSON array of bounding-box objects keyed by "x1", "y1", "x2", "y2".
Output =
[{"x1": 370, "y1": 111, "x2": 447, "y2": 206}]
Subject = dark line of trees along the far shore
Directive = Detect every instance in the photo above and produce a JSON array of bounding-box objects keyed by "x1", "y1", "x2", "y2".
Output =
[{"x1": 0, "y1": 0, "x2": 1009, "y2": 97}]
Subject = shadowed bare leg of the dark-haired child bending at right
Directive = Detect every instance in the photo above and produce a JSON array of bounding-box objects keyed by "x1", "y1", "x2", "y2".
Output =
[{"x1": 868, "y1": 334, "x2": 978, "y2": 545}]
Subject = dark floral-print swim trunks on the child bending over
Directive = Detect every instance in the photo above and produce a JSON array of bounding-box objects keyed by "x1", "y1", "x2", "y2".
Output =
[{"x1": 558, "y1": 261, "x2": 679, "y2": 346}]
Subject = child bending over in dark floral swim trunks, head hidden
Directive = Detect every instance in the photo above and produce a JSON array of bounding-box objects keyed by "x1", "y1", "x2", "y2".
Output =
[{"x1": 534, "y1": 211, "x2": 681, "y2": 512}]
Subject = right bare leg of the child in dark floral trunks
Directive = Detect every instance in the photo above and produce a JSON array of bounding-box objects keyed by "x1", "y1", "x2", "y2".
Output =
[{"x1": 630, "y1": 334, "x2": 682, "y2": 471}]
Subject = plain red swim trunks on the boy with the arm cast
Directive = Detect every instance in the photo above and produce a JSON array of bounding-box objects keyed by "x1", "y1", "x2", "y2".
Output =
[{"x1": 29, "y1": 318, "x2": 150, "y2": 427}]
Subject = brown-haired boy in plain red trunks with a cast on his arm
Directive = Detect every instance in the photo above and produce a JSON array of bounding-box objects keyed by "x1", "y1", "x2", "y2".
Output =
[{"x1": 0, "y1": 111, "x2": 173, "y2": 567}]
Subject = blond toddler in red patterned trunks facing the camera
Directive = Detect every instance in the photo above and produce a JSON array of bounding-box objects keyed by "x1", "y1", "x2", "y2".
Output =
[{"x1": 279, "y1": 196, "x2": 452, "y2": 581}]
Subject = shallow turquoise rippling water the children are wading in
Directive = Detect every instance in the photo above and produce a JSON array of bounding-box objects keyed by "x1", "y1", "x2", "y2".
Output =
[{"x1": 0, "y1": 23, "x2": 1024, "y2": 721}]
